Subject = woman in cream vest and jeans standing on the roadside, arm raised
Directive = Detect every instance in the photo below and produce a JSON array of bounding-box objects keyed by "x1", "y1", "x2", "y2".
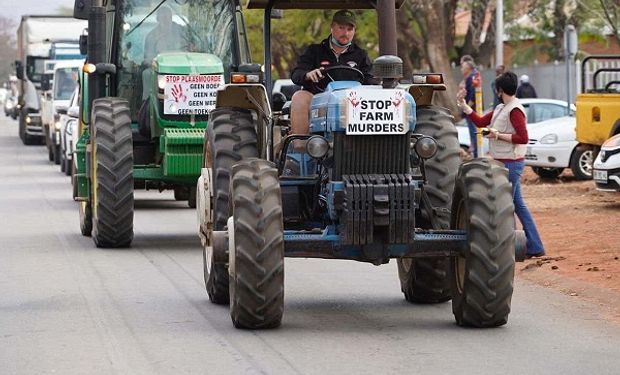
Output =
[{"x1": 457, "y1": 72, "x2": 545, "y2": 258}]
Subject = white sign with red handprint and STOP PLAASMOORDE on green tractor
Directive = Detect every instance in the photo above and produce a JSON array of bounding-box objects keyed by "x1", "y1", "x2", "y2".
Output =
[{"x1": 164, "y1": 74, "x2": 224, "y2": 115}]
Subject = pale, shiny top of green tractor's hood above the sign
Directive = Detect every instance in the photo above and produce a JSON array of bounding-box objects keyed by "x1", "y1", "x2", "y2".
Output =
[{"x1": 154, "y1": 52, "x2": 224, "y2": 74}]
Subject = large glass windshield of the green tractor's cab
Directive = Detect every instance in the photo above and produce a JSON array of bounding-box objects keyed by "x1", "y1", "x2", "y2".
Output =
[{"x1": 118, "y1": 0, "x2": 236, "y2": 117}]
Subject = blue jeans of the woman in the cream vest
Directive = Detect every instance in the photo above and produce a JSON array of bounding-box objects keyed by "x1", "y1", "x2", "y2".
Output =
[{"x1": 504, "y1": 160, "x2": 545, "y2": 255}]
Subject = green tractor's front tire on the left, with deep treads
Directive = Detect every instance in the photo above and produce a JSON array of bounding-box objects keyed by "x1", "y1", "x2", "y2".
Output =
[{"x1": 91, "y1": 98, "x2": 134, "y2": 248}]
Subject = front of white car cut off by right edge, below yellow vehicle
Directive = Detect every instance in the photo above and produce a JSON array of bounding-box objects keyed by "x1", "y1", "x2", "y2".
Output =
[{"x1": 592, "y1": 134, "x2": 620, "y2": 192}]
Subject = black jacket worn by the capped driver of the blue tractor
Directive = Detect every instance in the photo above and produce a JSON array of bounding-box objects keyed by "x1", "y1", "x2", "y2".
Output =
[{"x1": 291, "y1": 37, "x2": 372, "y2": 94}]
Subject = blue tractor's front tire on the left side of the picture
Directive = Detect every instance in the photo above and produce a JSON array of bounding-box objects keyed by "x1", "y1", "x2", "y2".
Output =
[{"x1": 228, "y1": 159, "x2": 284, "y2": 329}]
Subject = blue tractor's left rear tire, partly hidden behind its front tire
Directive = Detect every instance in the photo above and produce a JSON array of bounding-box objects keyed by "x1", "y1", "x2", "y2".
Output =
[{"x1": 203, "y1": 108, "x2": 258, "y2": 304}]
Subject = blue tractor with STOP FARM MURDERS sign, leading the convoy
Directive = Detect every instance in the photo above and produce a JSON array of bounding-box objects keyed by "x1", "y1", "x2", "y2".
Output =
[{"x1": 197, "y1": 0, "x2": 523, "y2": 329}]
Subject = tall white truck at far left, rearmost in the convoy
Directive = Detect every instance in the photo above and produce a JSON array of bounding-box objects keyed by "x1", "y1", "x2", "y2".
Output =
[{"x1": 15, "y1": 15, "x2": 88, "y2": 145}]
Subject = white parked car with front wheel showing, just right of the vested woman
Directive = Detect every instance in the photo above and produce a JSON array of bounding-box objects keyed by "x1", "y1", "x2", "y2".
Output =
[{"x1": 525, "y1": 116, "x2": 593, "y2": 180}]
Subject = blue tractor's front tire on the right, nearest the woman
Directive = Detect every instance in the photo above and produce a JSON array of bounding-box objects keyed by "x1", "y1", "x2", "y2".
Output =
[{"x1": 451, "y1": 159, "x2": 515, "y2": 328}]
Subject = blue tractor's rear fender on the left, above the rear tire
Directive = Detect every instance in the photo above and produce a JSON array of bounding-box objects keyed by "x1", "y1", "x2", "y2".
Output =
[{"x1": 215, "y1": 84, "x2": 271, "y2": 118}]
